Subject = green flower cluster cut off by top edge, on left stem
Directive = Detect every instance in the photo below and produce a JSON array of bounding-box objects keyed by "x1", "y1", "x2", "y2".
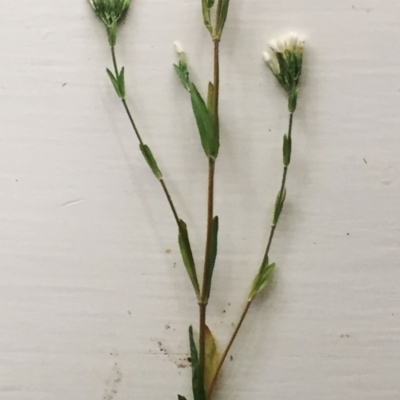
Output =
[{"x1": 89, "y1": 0, "x2": 131, "y2": 46}]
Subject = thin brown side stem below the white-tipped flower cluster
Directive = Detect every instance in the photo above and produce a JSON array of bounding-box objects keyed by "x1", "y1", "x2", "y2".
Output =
[{"x1": 207, "y1": 113, "x2": 293, "y2": 400}]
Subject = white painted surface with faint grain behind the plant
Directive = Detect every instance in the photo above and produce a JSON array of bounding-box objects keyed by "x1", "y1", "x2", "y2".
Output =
[{"x1": 0, "y1": 0, "x2": 400, "y2": 400}]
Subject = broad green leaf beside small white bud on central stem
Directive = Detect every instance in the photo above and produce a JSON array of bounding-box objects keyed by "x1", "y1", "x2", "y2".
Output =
[{"x1": 190, "y1": 83, "x2": 219, "y2": 160}]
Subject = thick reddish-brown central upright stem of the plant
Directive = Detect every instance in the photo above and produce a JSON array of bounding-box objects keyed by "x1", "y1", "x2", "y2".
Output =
[{"x1": 199, "y1": 0, "x2": 222, "y2": 375}]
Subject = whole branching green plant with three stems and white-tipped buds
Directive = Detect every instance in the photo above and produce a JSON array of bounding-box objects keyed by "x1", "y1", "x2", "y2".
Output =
[{"x1": 90, "y1": 0, "x2": 304, "y2": 400}]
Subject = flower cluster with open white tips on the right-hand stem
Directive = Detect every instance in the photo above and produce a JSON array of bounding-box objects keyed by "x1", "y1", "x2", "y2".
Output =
[{"x1": 264, "y1": 32, "x2": 304, "y2": 112}]
